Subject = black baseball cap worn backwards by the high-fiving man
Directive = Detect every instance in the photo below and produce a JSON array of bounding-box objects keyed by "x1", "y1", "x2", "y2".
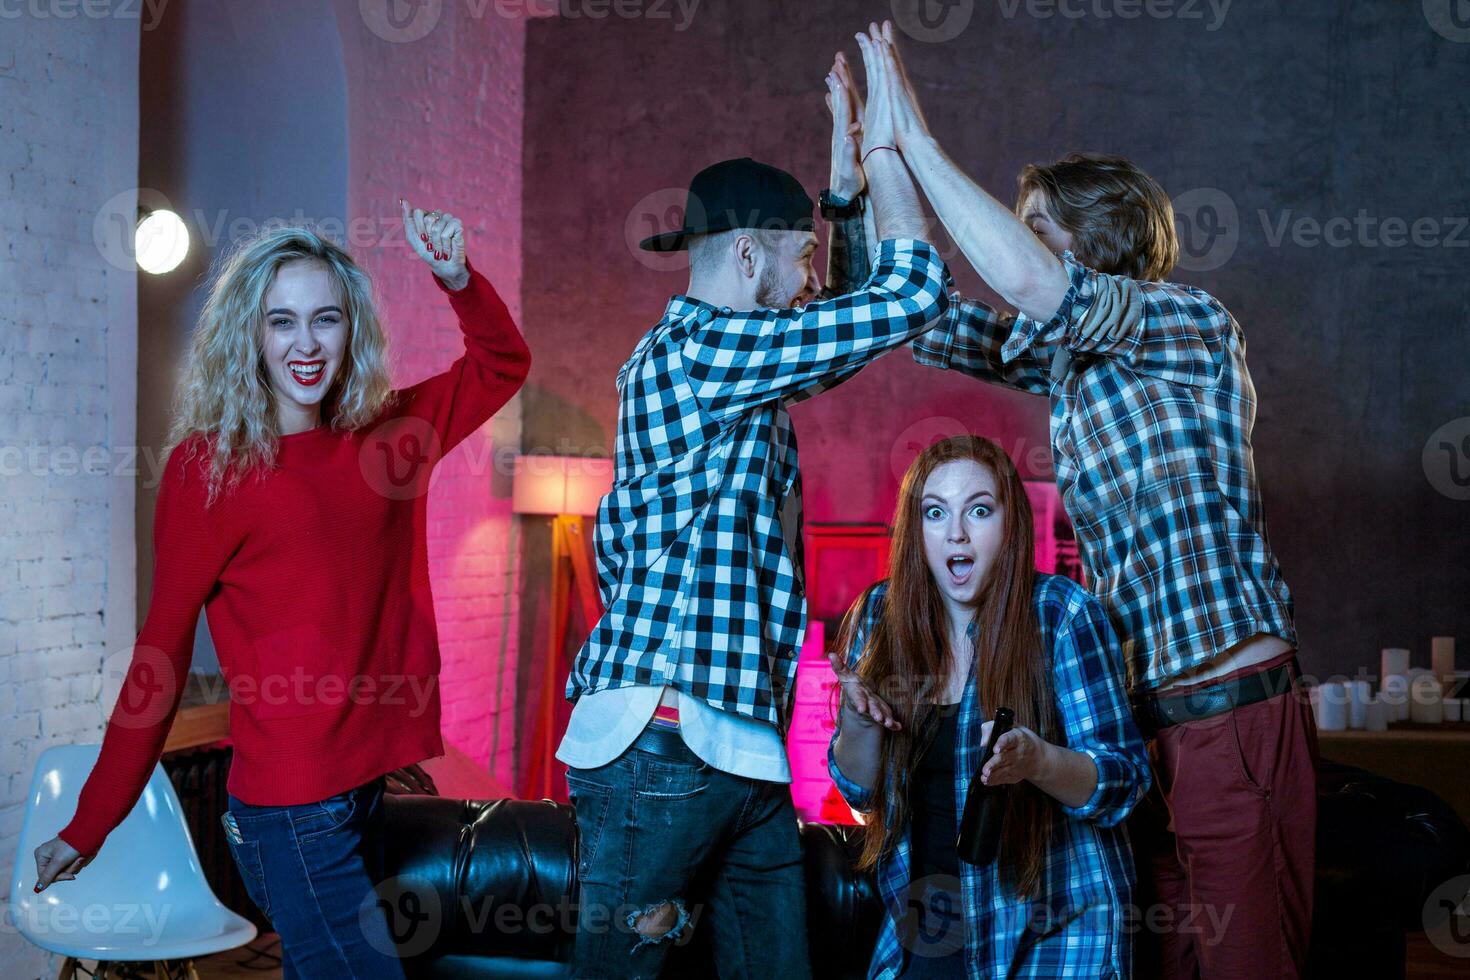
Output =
[{"x1": 638, "y1": 157, "x2": 816, "y2": 251}]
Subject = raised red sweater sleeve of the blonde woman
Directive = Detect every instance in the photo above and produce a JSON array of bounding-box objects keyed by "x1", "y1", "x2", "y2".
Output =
[{"x1": 398, "y1": 263, "x2": 531, "y2": 454}]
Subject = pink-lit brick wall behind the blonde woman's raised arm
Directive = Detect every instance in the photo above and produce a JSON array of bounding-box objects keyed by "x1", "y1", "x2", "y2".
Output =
[{"x1": 335, "y1": 0, "x2": 535, "y2": 785}]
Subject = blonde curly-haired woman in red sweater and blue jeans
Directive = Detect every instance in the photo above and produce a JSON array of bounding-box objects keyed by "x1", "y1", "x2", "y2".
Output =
[{"x1": 35, "y1": 203, "x2": 531, "y2": 980}]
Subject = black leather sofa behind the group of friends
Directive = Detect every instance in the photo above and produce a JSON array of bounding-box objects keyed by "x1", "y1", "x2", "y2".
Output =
[{"x1": 382, "y1": 761, "x2": 1470, "y2": 980}]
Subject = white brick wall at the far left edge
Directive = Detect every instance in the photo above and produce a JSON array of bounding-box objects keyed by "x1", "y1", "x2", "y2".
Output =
[{"x1": 0, "y1": 7, "x2": 138, "y2": 977}]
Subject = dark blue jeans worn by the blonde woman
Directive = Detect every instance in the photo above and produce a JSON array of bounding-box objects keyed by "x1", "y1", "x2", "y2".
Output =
[{"x1": 222, "y1": 779, "x2": 403, "y2": 980}]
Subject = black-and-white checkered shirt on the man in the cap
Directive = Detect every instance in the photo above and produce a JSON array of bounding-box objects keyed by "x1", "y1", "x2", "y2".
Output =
[{"x1": 566, "y1": 239, "x2": 948, "y2": 732}]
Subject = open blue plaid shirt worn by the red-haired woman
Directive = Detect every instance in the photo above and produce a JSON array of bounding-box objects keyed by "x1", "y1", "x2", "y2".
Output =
[{"x1": 828, "y1": 574, "x2": 1151, "y2": 980}]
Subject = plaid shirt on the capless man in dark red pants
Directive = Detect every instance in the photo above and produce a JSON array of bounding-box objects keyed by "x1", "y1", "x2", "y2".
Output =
[{"x1": 913, "y1": 253, "x2": 1297, "y2": 692}]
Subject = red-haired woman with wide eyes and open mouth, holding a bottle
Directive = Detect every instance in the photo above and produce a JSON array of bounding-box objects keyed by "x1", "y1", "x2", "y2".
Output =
[{"x1": 828, "y1": 436, "x2": 1150, "y2": 979}]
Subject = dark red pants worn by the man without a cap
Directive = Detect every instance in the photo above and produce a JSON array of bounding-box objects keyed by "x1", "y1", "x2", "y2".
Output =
[{"x1": 1129, "y1": 654, "x2": 1317, "y2": 980}]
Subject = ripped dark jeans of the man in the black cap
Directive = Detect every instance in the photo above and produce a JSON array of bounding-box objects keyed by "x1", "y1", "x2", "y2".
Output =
[{"x1": 566, "y1": 733, "x2": 810, "y2": 980}]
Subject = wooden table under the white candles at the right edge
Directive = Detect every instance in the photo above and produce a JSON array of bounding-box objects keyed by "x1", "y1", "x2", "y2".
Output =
[{"x1": 1317, "y1": 724, "x2": 1470, "y2": 824}]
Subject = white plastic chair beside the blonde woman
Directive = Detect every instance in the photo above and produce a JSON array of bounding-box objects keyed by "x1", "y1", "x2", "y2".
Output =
[{"x1": 9, "y1": 745, "x2": 256, "y2": 977}]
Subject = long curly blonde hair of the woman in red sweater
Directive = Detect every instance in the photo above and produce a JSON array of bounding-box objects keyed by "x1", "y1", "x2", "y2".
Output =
[{"x1": 168, "y1": 228, "x2": 392, "y2": 502}]
